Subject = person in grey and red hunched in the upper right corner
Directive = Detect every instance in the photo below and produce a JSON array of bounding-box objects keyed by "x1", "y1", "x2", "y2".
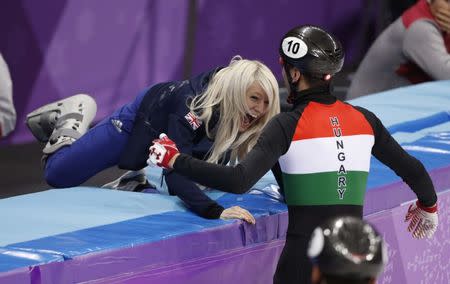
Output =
[{"x1": 346, "y1": 0, "x2": 450, "y2": 99}]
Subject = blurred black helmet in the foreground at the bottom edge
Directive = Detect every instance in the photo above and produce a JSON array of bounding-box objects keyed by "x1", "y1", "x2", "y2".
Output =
[{"x1": 308, "y1": 216, "x2": 387, "y2": 279}]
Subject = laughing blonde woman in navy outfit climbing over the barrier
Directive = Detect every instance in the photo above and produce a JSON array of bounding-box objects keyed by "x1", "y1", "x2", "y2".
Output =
[{"x1": 27, "y1": 56, "x2": 279, "y2": 222}]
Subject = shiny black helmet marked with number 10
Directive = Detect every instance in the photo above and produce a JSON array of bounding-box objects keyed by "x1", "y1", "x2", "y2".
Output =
[{"x1": 280, "y1": 25, "x2": 344, "y2": 80}]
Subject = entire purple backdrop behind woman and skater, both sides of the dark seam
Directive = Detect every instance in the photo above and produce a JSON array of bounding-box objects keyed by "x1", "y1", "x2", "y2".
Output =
[{"x1": 0, "y1": 0, "x2": 370, "y2": 145}]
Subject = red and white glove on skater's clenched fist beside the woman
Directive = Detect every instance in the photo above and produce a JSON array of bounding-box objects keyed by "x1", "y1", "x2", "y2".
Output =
[{"x1": 147, "y1": 133, "x2": 180, "y2": 169}]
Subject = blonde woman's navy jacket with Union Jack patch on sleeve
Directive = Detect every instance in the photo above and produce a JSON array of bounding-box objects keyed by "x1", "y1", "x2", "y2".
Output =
[{"x1": 119, "y1": 68, "x2": 224, "y2": 219}]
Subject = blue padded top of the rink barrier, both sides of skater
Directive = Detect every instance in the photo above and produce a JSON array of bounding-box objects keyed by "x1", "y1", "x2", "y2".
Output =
[{"x1": 0, "y1": 81, "x2": 450, "y2": 272}]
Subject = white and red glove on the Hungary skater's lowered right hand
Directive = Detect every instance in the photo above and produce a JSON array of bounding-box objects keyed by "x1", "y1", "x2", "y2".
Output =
[{"x1": 405, "y1": 201, "x2": 438, "y2": 239}]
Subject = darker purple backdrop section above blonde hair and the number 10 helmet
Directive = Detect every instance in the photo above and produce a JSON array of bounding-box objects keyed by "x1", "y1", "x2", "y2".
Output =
[{"x1": 193, "y1": 0, "x2": 364, "y2": 78}]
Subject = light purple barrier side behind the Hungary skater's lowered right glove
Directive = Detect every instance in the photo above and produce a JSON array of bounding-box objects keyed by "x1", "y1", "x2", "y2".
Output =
[{"x1": 366, "y1": 190, "x2": 450, "y2": 284}]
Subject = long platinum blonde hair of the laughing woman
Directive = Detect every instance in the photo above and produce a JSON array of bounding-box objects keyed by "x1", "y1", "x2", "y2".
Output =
[{"x1": 190, "y1": 56, "x2": 280, "y2": 164}]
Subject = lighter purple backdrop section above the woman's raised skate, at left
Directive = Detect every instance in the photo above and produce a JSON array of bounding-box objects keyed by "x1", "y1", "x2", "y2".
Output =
[{"x1": 0, "y1": 0, "x2": 188, "y2": 143}]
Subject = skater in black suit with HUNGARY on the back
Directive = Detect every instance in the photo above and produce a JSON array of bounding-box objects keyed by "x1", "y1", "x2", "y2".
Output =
[{"x1": 149, "y1": 26, "x2": 438, "y2": 284}]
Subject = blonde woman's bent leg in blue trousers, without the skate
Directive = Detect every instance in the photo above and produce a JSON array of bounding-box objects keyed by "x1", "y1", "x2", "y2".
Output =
[{"x1": 45, "y1": 93, "x2": 145, "y2": 187}]
